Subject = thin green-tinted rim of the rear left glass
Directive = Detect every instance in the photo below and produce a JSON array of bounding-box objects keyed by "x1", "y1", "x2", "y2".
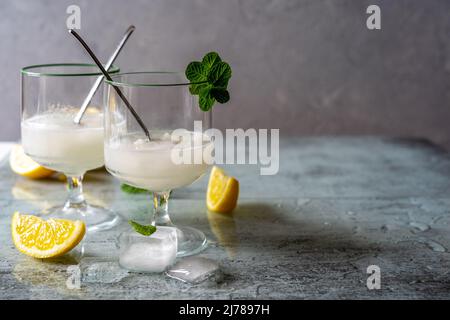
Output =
[{"x1": 20, "y1": 63, "x2": 120, "y2": 77}]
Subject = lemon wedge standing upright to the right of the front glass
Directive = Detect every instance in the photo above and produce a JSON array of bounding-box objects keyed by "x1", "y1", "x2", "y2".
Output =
[{"x1": 206, "y1": 166, "x2": 239, "y2": 213}]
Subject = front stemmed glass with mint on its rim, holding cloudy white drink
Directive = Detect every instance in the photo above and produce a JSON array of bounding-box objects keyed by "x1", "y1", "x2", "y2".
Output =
[{"x1": 105, "y1": 72, "x2": 214, "y2": 256}]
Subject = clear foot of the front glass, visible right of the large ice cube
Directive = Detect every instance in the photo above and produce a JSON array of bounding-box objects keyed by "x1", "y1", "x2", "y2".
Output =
[{"x1": 175, "y1": 226, "x2": 208, "y2": 257}]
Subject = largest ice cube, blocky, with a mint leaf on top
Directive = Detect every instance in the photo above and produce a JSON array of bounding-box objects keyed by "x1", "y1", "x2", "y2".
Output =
[{"x1": 119, "y1": 227, "x2": 177, "y2": 272}]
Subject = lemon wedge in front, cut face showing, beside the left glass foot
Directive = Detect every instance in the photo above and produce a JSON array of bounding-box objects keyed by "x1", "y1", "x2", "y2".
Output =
[{"x1": 11, "y1": 212, "x2": 86, "y2": 259}]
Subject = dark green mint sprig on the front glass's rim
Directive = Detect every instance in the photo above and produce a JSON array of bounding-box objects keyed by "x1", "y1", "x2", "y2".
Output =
[{"x1": 185, "y1": 52, "x2": 231, "y2": 111}]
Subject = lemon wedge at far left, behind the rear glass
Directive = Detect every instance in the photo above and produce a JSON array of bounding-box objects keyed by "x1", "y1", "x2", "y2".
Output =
[{"x1": 9, "y1": 144, "x2": 53, "y2": 179}]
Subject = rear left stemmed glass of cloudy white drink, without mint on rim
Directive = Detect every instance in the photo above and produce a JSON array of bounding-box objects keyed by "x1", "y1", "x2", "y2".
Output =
[{"x1": 21, "y1": 63, "x2": 119, "y2": 231}]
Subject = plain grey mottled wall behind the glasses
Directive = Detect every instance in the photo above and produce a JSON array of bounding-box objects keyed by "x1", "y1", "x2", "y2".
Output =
[{"x1": 0, "y1": 0, "x2": 450, "y2": 147}]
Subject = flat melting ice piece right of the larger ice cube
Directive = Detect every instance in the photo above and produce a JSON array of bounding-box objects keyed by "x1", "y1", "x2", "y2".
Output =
[{"x1": 166, "y1": 257, "x2": 219, "y2": 284}]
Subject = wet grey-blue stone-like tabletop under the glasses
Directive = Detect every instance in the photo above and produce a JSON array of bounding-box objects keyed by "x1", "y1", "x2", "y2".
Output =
[{"x1": 0, "y1": 137, "x2": 450, "y2": 299}]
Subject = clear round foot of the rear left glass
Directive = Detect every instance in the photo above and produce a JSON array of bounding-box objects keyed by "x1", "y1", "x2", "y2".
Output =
[{"x1": 40, "y1": 205, "x2": 120, "y2": 232}]
